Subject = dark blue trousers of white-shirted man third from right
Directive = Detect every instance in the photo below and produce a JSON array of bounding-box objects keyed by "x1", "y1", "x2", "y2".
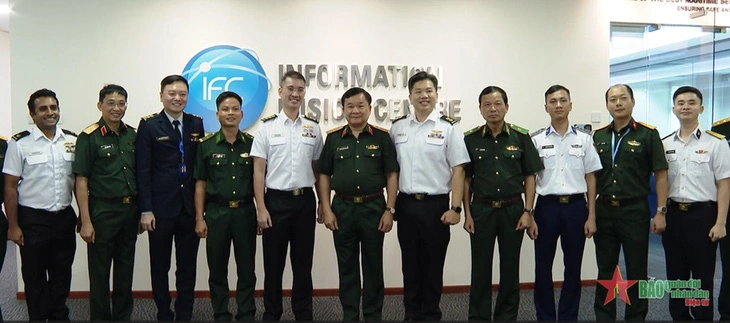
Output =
[{"x1": 535, "y1": 196, "x2": 588, "y2": 321}]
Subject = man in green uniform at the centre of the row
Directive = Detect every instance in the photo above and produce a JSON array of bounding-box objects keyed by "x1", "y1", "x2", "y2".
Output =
[{"x1": 317, "y1": 87, "x2": 399, "y2": 321}]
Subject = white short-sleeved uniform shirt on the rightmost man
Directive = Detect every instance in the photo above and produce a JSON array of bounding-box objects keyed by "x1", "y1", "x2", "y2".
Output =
[{"x1": 662, "y1": 127, "x2": 730, "y2": 203}]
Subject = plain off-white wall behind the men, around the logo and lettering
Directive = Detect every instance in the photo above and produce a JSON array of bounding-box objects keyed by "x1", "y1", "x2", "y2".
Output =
[{"x1": 7, "y1": 0, "x2": 609, "y2": 290}]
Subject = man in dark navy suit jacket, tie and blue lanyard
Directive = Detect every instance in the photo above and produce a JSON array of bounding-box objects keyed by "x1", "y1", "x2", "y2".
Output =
[{"x1": 136, "y1": 75, "x2": 204, "y2": 321}]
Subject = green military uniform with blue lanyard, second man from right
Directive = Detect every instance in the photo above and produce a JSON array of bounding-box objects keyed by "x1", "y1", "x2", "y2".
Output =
[{"x1": 593, "y1": 118, "x2": 668, "y2": 320}]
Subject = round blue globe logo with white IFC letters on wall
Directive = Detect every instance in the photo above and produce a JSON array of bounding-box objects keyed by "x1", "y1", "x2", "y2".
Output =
[{"x1": 182, "y1": 45, "x2": 271, "y2": 132}]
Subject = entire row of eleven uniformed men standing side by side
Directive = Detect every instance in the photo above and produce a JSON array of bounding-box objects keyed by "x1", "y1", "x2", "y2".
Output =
[{"x1": 0, "y1": 71, "x2": 730, "y2": 320}]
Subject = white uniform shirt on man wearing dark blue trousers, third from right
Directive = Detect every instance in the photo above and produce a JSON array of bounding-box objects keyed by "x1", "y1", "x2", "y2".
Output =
[{"x1": 531, "y1": 126, "x2": 603, "y2": 196}]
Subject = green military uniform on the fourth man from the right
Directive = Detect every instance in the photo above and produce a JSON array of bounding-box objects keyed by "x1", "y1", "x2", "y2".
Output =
[{"x1": 464, "y1": 123, "x2": 544, "y2": 321}]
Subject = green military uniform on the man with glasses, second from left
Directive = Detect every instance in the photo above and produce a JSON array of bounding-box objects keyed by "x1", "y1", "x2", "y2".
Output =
[{"x1": 72, "y1": 119, "x2": 139, "y2": 321}]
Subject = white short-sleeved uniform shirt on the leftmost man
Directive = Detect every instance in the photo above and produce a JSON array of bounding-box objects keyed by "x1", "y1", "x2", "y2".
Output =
[{"x1": 3, "y1": 126, "x2": 76, "y2": 212}]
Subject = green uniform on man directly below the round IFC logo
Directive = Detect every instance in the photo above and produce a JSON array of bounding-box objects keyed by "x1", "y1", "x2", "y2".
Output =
[{"x1": 193, "y1": 131, "x2": 257, "y2": 321}]
